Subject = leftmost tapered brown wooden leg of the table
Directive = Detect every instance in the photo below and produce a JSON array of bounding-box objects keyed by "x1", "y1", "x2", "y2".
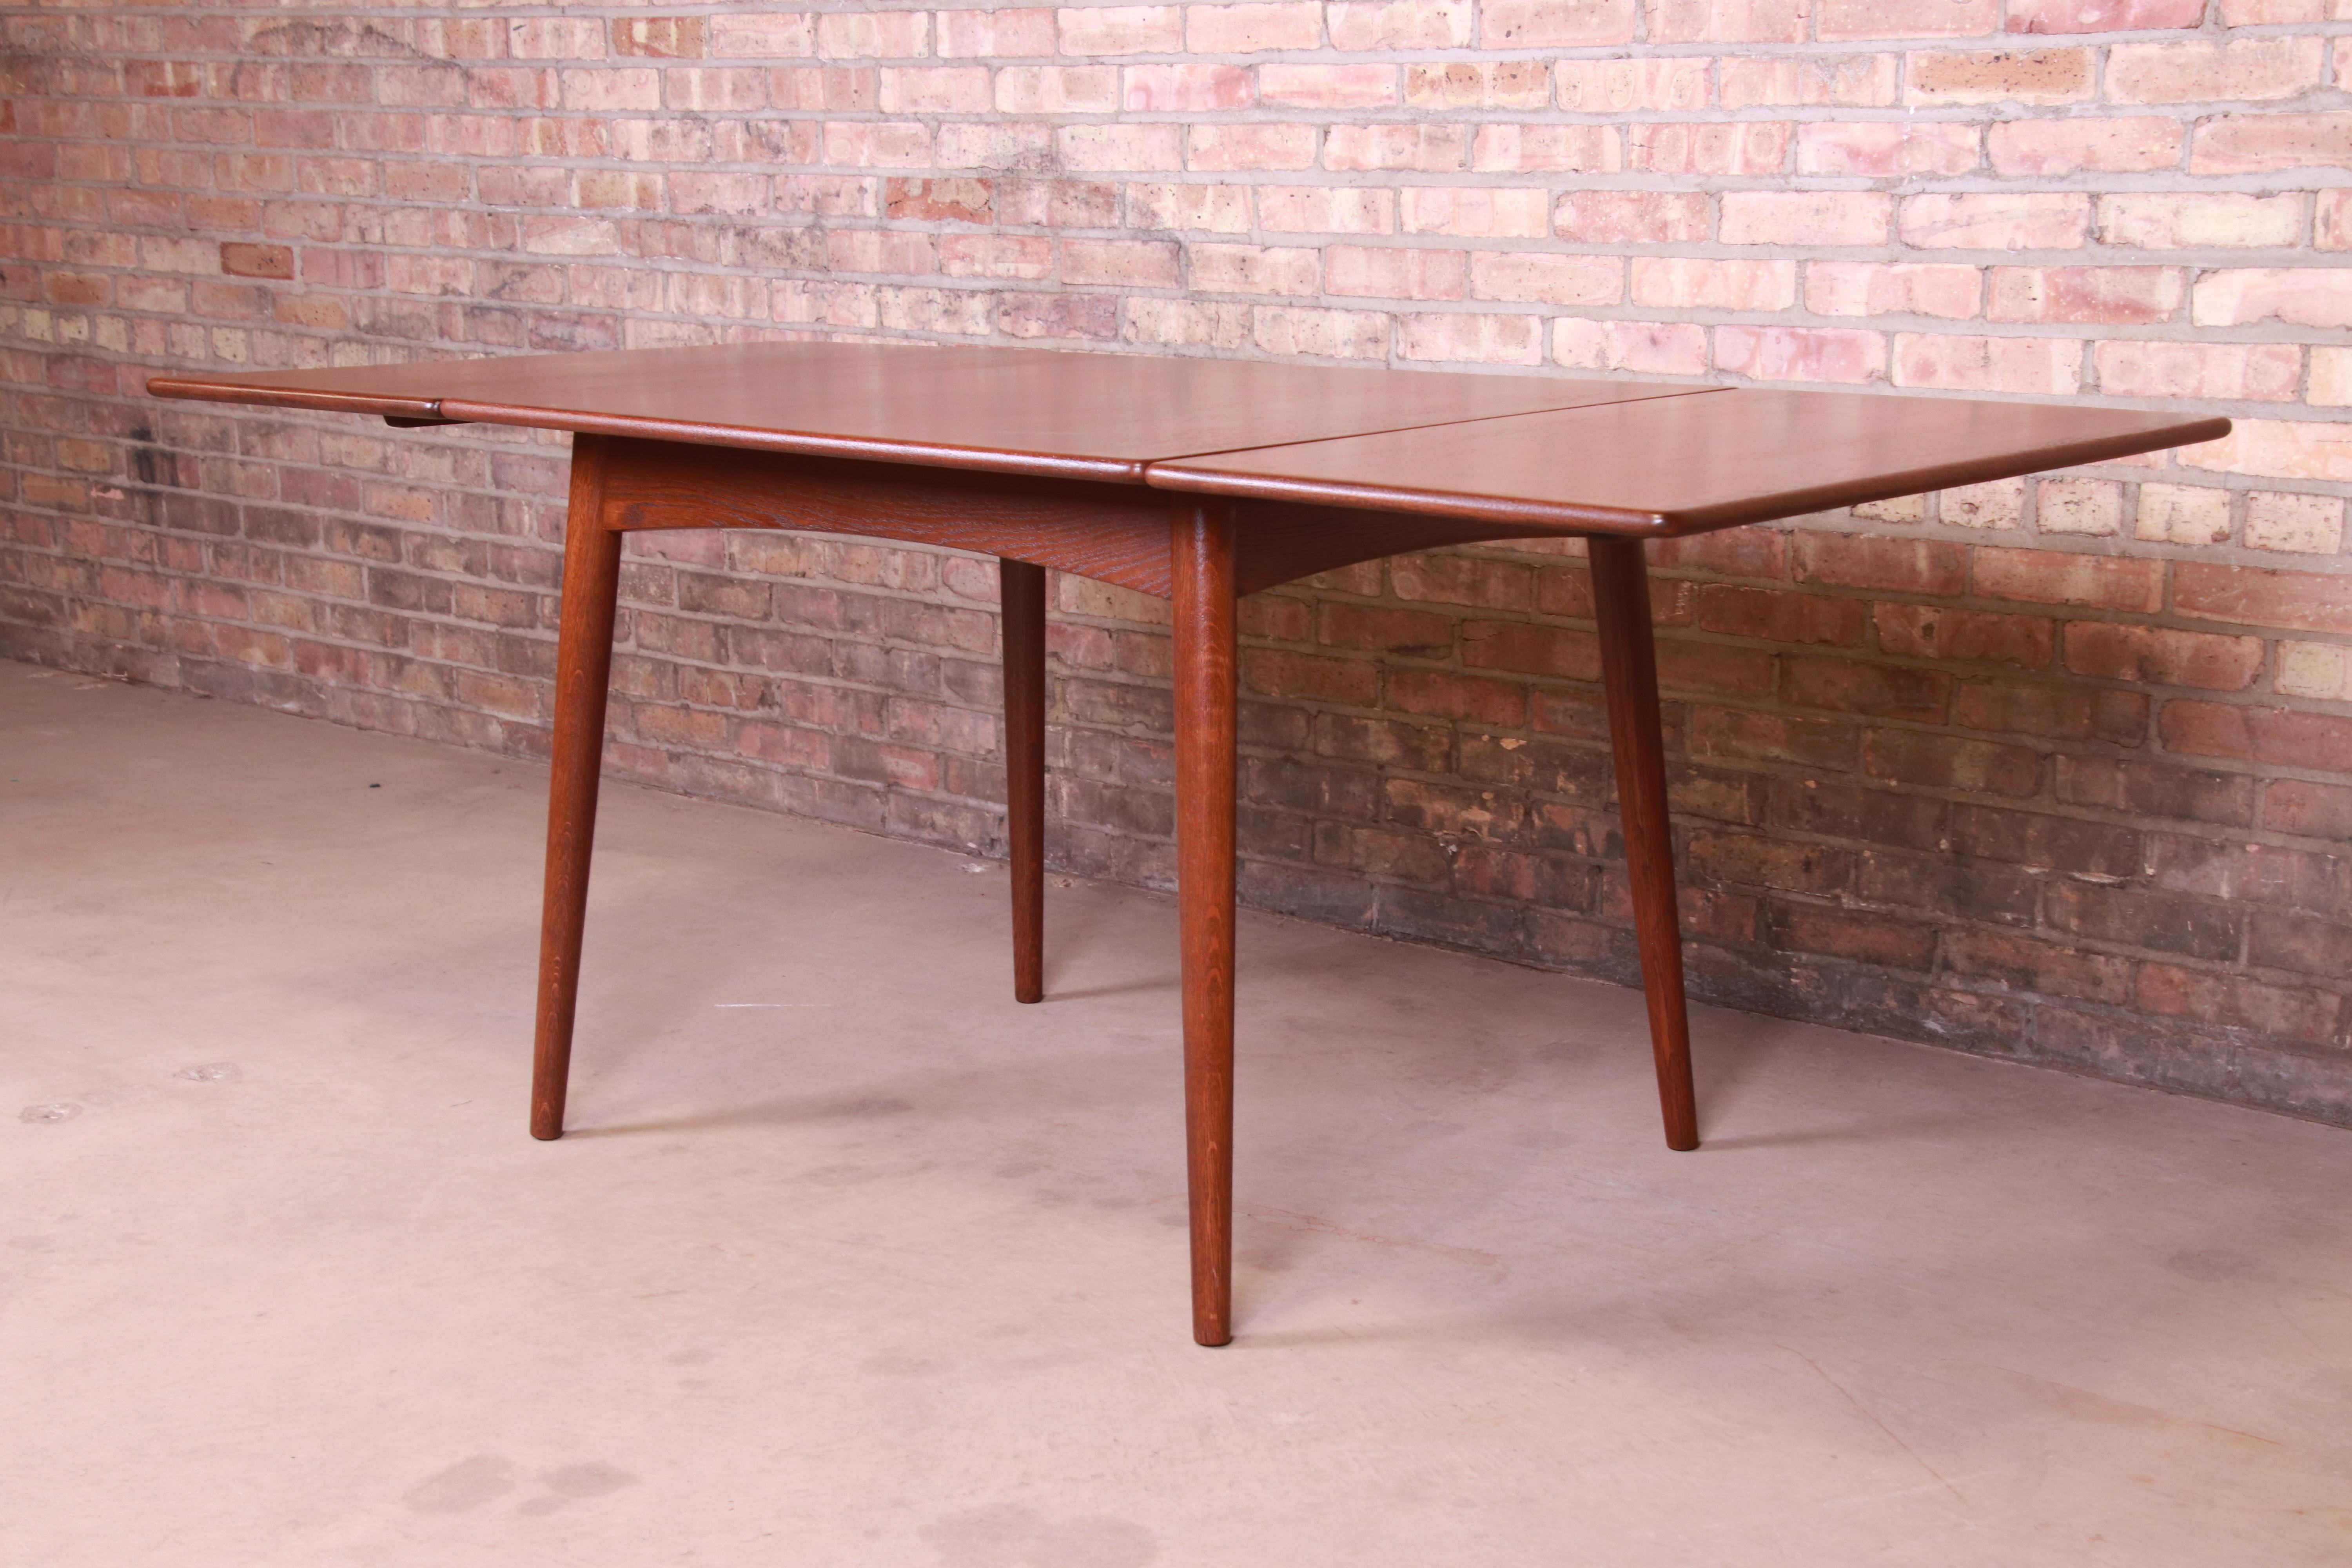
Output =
[{"x1": 532, "y1": 435, "x2": 621, "y2": 1138}]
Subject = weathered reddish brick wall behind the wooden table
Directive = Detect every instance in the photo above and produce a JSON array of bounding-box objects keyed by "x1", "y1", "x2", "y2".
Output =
[{"x1": 0, "y1": 0, "x2": 2352, "y2": 1122}]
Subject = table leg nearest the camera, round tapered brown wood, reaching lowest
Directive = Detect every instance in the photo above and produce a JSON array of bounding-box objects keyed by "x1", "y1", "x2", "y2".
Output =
[{"x1": 1171, "y1": 496, "x2": 1235, "y2": 1345}]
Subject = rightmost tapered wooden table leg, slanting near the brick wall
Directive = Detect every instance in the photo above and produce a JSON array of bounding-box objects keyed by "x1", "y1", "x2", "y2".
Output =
[{"x1": 1588, "y1": 538, "x2": 1698, "y2": 1150}]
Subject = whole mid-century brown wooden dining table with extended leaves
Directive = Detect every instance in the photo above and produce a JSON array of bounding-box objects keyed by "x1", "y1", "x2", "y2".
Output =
[{"x1": 148, "y1": 343, "x2": 2230, "y2": 1345}]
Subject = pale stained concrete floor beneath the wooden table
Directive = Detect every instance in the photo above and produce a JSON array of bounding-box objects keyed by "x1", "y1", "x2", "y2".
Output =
[{"x1": 0, "y1": 663, "x2": 2352, "y2": 1568}]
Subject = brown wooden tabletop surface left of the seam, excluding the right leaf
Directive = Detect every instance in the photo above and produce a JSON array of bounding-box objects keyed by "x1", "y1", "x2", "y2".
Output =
[{"x1": 148, "y1": 343, "x2": 1691, "y2": 484}]
